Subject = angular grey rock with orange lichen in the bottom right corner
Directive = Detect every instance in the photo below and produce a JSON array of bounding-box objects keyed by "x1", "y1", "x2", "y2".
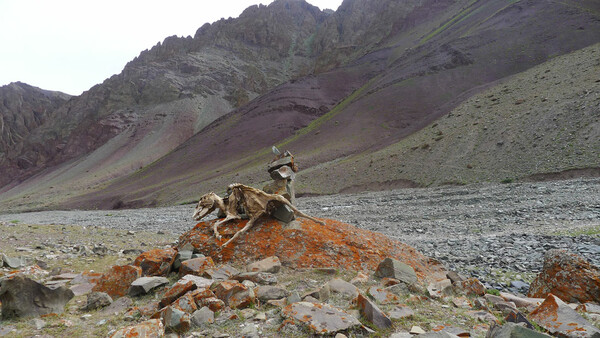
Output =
[{"x1": 529, "y1": 294, "x2": 600, "y2": 337}]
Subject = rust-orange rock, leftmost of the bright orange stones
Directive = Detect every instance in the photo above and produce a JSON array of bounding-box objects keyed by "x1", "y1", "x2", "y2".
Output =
[{"x1": 92, "y1": 265, "x2": 142, "y2": 299}]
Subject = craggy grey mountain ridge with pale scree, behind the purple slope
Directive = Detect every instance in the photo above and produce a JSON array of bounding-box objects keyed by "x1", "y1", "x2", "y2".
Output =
[{"x1": 0, "y1": 0, "x2": 327, "y2": 190}]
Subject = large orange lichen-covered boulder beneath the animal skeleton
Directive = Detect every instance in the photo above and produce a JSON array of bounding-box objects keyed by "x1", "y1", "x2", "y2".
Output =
[{"x1": 179, "y1": 218, "x2": 445, "y2": 280}]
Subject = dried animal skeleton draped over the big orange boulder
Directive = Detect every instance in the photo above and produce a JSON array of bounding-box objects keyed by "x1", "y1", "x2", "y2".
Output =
[{"x1": 193, "y1": 183, "x2": 325, "y2": 247}]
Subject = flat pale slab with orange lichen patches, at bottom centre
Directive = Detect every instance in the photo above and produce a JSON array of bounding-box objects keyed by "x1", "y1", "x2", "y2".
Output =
[{"x1": 281, "y1": 302, "x2": 361, "y2": 334}]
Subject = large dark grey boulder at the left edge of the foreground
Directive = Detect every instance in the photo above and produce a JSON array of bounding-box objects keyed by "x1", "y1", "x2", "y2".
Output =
[{"x1": 0, "y1": 275, "x2": 74, "y2": 318}]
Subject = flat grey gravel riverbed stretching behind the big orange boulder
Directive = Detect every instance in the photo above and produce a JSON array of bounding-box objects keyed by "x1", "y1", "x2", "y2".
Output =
[{"x1": 0, "y1": 178, "x2": 600, "y2": 293}]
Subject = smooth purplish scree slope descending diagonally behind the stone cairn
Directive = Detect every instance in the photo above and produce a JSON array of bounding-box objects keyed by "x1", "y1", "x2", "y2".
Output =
[{"x1": 57, "y1": 1, "x2": 600, "y2": 208}]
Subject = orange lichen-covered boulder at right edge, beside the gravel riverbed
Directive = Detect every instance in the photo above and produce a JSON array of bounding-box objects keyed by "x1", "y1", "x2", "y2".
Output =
[{"x1": 528, "y1": 249, "x2": 600, "y2": 303}]
